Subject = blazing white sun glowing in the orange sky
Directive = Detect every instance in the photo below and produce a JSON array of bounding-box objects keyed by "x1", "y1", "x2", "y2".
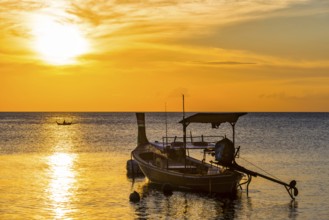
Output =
[{"x1": 32, "y1": 15, "x2": 89, "y2": 65}]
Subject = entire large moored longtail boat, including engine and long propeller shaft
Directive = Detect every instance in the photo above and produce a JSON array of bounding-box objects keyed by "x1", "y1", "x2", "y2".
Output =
[{"x1": 132, "y1": 113, "x2": 298, "y2": 199}]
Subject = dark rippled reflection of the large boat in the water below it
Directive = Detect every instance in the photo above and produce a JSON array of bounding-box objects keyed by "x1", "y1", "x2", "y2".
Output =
[{"x1": 134, "y1": 182, "x2": 247, "y2": 219}]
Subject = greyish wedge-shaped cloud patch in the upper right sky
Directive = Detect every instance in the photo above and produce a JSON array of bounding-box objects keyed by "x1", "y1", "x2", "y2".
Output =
[{"x1": 182, "y1": 0, "x2": 329, "y2": 61}]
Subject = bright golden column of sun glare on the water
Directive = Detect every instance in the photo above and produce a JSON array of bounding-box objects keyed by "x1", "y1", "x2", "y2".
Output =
[{"x1": 46, "y1": 115, "x2": 79, "y2": 219}]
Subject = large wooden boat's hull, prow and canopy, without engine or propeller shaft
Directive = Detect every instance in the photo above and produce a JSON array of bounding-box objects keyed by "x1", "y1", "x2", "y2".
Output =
[{"x1": 132, "y1": 113, "x2": 243, "y2": 194}]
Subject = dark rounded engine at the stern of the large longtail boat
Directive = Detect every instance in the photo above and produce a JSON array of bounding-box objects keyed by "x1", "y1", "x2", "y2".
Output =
[{"x1": 215, "y1": 138, "x2": 235, "y2": 166}]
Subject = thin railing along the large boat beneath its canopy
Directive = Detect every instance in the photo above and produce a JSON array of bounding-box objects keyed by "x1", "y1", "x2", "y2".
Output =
[{"x1": 162, "y1": 135, "x2": 225, "y2": 147}]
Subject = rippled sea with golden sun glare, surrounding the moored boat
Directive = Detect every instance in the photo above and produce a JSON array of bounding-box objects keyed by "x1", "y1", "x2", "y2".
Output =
[{"x1": 0, "y1": 112, "x2": 329, "y2": 219}]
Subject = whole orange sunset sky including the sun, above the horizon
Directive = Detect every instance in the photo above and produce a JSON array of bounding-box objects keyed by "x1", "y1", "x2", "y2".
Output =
[{"x1": 0, "y1": 0, "x2": 329, "y2": 112}]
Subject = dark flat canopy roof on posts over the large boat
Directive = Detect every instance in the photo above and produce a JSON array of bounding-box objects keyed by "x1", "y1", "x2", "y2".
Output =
[{"x1": 179, "y1": 113, "x2": 247, "y2": 128}]
